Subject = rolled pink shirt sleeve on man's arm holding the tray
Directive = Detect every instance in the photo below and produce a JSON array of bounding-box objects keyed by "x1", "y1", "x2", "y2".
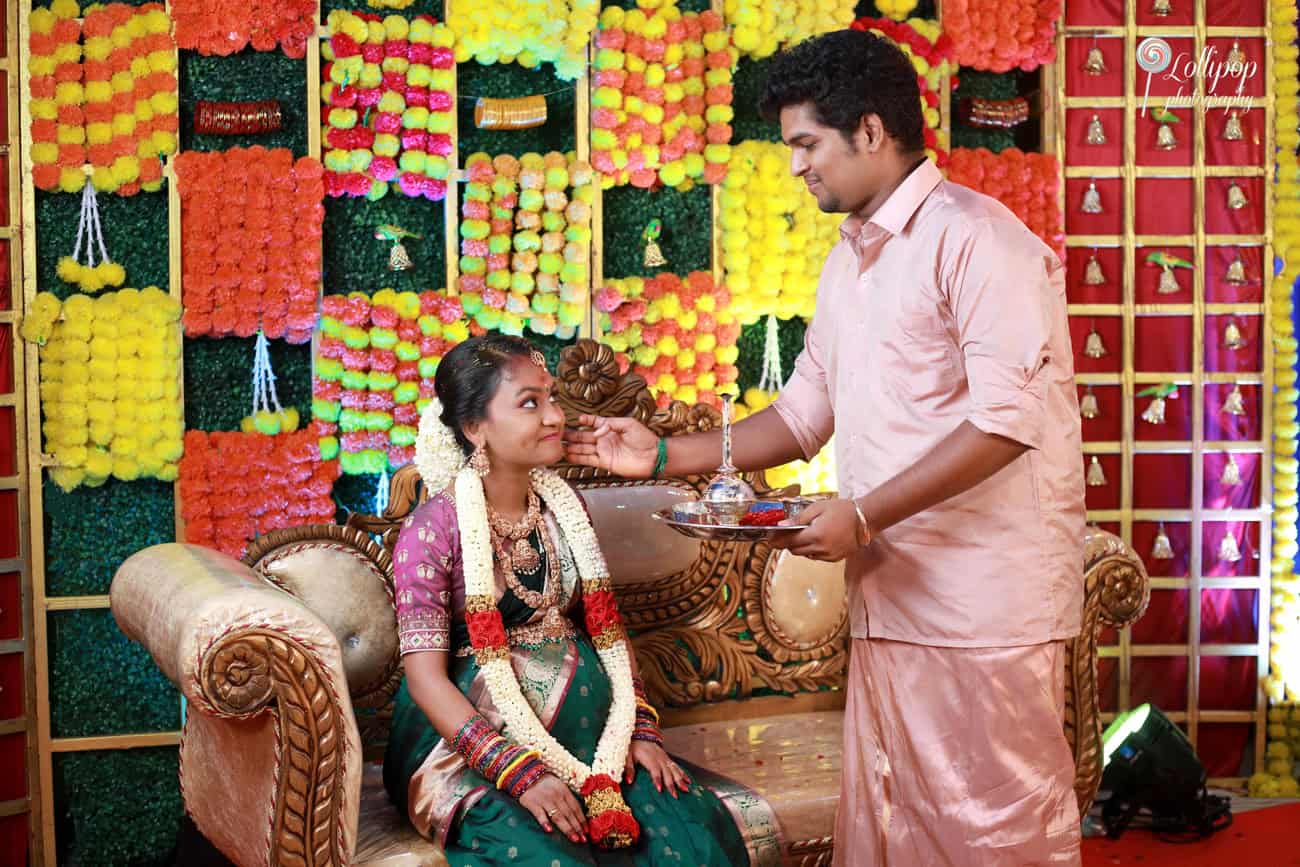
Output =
[{"x1": 948, "y1": 220, "x2": 1065, "y2": 448}]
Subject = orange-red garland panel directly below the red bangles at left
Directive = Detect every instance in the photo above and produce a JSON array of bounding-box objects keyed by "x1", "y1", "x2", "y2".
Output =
[{"x1": 176, "y1": 147, "x2": 325, "y2": 343}]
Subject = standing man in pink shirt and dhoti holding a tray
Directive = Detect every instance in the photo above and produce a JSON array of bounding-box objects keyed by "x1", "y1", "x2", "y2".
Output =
[{"x1": 568, "y1": 30, "x2": 1084, "y2": 867}]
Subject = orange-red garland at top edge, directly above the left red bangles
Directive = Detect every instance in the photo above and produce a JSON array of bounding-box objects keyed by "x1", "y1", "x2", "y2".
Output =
[{"x1": 172, "y1": 0, "x2": 316, "y2": 57}]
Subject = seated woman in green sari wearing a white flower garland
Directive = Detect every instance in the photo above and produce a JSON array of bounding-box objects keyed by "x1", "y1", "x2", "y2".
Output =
[{"x1": 384, "y1": 334, "x2": 748, "y2": 867}]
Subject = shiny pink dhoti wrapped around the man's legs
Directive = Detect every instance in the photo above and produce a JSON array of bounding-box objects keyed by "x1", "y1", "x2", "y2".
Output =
[{"x1": 835, "y1": 638, "x2": 1080, "y2": 867}]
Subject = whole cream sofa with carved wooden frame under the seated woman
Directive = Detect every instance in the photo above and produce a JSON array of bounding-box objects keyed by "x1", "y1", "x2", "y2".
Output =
[{"x1": 112, "y1": 342, "x2": 1149, "y2": 867}]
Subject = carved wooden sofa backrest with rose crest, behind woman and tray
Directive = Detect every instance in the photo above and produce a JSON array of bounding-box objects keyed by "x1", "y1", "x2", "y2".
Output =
[{"x1": 348, "y1": 341, "x2": 848, "y2": 707}]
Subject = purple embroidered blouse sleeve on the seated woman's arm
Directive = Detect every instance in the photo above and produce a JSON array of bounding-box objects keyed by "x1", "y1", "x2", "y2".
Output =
[{"x1": 393, "y1": 495, "x2": 460, "y2": 655}]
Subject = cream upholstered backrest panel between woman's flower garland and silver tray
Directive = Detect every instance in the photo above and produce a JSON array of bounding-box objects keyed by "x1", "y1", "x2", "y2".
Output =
[{"x1": 579, "y1": 484, "x2": 699, "y2": 586}]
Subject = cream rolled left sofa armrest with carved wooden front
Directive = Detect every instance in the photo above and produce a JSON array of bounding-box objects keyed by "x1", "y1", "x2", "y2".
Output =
[{"x1": 111, "y1": 543, "x2": 361, "y2": 867}]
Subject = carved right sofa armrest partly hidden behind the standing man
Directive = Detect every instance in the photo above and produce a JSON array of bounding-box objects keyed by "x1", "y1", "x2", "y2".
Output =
[{"x1": 1065, "y1": 528, "x2": 1151, "y2": 814}]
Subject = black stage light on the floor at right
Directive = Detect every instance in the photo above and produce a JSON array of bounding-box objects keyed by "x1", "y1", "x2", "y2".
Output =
[{"x1": 1101, "y1": 705, "x2": 1232, "y2": 840}]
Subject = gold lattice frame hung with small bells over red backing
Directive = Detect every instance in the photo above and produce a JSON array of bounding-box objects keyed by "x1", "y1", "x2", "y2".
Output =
[{"x1": 1043, "y1": 0, "x2": 1274, "y2": 785}]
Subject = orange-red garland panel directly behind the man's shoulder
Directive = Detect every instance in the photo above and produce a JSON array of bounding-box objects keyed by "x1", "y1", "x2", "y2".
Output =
[{"x1": 948, "y1": 147, "x2": 1065, "y2": 261}]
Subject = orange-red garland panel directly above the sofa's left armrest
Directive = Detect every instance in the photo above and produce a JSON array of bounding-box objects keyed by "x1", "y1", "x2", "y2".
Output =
[{"x1": 181, "y1": 428, "x2": 339, "y2": 558}]
